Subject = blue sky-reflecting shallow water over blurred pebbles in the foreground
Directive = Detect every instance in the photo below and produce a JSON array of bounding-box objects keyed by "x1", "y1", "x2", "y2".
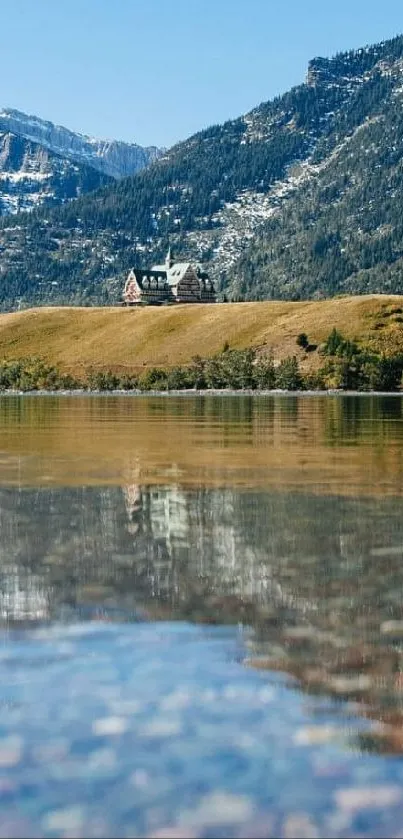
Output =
[{"x1": 0, "y1": 622, "x2": 403, "y2": 837}]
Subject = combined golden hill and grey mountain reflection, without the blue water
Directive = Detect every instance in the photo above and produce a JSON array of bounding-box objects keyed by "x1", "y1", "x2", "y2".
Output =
[{"x1": 0, "y1": 396, "x2": 403, "y2": 768}]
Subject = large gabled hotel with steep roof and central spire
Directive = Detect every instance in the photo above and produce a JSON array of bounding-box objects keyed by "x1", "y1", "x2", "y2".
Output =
[{"x1": 123, "y1": 248, "x2": 216, "y2": 306}]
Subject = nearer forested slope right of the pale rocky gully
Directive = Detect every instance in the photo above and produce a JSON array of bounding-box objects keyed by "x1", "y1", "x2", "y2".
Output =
[{"x1": 231, "y1": 62, "x2": 403, "y2": 300}]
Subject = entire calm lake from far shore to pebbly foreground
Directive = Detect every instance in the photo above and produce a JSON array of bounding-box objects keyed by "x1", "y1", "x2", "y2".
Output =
[{"x1": 0, "y1": 395, "x2": 403, "y2": 839}]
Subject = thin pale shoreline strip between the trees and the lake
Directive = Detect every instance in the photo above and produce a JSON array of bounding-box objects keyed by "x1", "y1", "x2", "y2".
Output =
[{"x1": 0, "y1": 388, "x2": 403, "y2": 398}]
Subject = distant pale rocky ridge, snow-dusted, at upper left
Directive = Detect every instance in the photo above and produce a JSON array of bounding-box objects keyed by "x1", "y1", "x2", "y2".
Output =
[{"x1": 0, "y1": 108, "x2": 162, "y2": 178}]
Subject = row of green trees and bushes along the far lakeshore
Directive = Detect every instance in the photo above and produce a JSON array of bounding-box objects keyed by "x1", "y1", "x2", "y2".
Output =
[{"x1": 0, "y1": 329, "x2": 403, "y2": 392}]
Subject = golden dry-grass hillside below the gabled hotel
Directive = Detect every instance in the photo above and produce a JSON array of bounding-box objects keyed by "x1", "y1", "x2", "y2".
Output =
[{"x1": 0, "y1": 295, "x2": 403, "y2": 375}]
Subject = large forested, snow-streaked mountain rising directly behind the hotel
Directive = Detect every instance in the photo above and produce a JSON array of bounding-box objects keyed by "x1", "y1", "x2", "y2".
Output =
[{"x1": 0, "y1": 36, "x2": 403, "y2": 309}]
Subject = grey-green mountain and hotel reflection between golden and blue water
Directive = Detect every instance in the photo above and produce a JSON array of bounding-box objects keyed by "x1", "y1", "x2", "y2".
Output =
[{"x1": 0, "y1": 484, "x2": 403, "y2": 751}]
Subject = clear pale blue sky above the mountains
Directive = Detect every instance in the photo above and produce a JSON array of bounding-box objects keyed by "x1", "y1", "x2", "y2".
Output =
[{"x1": 0, "y1": 0, "x2": 403, "y2": 146}]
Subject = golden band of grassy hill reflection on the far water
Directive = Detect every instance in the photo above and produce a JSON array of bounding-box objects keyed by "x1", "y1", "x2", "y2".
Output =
[{"x1": 0, "y1": 395, "x2": 403, "y2": 496}]
